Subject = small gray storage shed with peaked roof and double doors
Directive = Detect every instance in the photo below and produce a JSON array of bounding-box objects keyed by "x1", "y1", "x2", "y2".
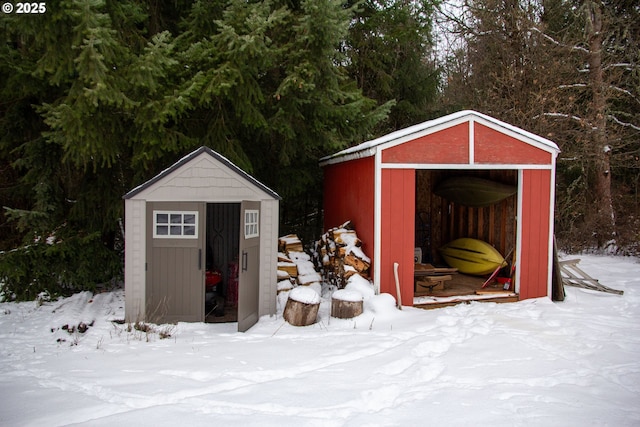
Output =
[{"x1": 124, "y1": 147, "x2": 280, "y2": 331}]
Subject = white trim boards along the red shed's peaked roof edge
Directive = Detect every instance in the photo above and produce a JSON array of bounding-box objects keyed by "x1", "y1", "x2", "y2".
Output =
[{"x1": 320, "y1": 110, "x2": 560, "y2": 166}]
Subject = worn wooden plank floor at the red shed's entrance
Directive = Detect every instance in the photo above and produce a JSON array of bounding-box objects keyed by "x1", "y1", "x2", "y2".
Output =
[{"x1": 413, "y1": 274, "x2": 518, "y2": 309}]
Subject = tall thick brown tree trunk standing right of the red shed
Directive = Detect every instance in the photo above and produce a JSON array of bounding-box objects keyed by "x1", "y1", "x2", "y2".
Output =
[{"x1": 585, "y1": 0, "x2": 615, "y2": 247}]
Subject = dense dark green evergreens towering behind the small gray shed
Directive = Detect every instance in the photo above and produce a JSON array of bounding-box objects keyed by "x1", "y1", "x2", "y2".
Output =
[{"x1": 0, "y1": 0, "x2": 389, "y2": 298}]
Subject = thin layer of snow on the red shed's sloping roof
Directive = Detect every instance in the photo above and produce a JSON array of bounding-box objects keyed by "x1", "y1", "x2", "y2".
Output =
[{"x1": 320, "y1": 110, "x2": 560, "y2": 166}]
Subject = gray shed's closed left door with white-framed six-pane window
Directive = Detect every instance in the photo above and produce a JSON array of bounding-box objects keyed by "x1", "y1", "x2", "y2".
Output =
[{"x1": 146, "y1": 202, "x2": 205, "y2": 323}]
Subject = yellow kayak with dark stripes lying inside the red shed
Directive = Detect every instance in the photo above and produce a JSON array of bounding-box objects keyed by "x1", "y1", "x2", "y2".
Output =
[{"x1": 439, "y1": 237, "x2": 507, "y2": 276}]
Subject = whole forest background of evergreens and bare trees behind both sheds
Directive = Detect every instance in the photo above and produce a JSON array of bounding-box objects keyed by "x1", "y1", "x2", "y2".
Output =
[{"x1": 0, "y1": 0, "x2": 640, "y2": 299}]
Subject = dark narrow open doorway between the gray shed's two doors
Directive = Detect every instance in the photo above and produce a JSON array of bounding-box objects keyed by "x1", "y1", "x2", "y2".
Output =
[{"x1": 204, "y1": 203, "x2": 241, "y2": 323}]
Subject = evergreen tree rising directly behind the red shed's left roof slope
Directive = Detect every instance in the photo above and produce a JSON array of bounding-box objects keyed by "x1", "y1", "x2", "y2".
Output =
[{"x1": 344, "y1": 0, "x2": 440, "y2": 134}]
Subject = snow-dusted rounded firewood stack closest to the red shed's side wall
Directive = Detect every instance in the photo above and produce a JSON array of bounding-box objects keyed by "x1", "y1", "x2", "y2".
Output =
[{"x1": 313, "y1": 221, "x2": 371, "y2": 289}]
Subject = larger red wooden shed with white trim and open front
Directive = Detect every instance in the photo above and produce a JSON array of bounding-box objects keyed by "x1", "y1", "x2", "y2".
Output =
[{"x1": 320, "y1": 111, "x2": 559, "y2": 305}]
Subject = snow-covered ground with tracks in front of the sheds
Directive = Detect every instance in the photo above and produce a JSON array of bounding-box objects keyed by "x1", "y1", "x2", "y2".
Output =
[{"x1": 0, "y1": 255, "x2": 640, "y2": 426}]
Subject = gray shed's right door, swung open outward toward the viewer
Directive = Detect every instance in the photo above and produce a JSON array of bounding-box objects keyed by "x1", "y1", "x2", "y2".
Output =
[{"x1": 238, "y1": 201, "x2": 261, "y2": 332}]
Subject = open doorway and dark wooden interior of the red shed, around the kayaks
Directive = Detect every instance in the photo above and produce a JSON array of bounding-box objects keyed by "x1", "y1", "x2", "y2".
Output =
[{"x1": 414, "y1": 169, "x2": 518, "y2": 298}]
